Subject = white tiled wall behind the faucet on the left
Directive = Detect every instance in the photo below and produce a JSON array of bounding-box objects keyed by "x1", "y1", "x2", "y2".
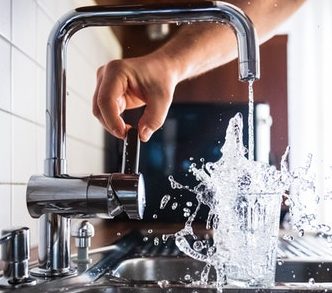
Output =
[{"x1": 0, "y1": 0, "x2": 120, "y2": 244}]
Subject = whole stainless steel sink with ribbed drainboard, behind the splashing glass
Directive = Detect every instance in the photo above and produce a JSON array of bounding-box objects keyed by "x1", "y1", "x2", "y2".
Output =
[{"x1": 0, "y1": 232, "x2": 332, "y2": 293}]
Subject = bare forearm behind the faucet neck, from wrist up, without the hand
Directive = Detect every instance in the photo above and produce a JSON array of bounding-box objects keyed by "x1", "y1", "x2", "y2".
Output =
[{"x1": 152, "y1": 0, "x2": 304, "y2": 81}]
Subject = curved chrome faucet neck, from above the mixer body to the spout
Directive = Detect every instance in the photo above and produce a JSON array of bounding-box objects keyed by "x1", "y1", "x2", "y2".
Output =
[{"x1": 45, "y1": 1, "x2": 259, "y2": 177}]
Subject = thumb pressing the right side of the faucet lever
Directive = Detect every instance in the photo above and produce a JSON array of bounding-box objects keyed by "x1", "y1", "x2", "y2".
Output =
[{"x1": 138, "y1": 91, "x2": 171, "y2": 142}]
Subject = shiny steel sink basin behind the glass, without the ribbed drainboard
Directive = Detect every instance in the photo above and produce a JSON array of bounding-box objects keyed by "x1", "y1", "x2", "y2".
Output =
[{"x1": 113, "y1": 256, "x2": 332, "y2": 285}]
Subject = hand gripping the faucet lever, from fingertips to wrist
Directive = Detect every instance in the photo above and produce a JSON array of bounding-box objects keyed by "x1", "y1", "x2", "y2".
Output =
[{"x1": 93, "y1": 54, "x2": 177, "y2": 142}]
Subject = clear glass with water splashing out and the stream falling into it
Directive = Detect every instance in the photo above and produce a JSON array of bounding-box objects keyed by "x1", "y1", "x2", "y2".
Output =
[{"x1": 159, "y1": 83, "x2": 329, "y2": 289}]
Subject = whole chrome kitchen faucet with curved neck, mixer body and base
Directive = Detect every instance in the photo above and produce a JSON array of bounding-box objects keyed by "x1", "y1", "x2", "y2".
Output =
[{"x1": 27, "y1": 1, "x2": 259, "y2": 276}]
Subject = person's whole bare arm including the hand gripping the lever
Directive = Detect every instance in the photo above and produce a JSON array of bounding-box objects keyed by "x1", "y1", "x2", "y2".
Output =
[{"x1": 93, "y1": 0, "x2": 304, "y2": 141}]
